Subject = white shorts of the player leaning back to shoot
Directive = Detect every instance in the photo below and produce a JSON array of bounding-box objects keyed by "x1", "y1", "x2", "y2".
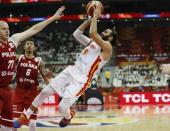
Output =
[{"x1": 50, "y1": 66, "x2": 86, "y2": 98}]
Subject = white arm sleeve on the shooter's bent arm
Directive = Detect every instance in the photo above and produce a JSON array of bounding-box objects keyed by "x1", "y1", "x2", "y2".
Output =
[{"x1": 73, "y1": 29, "x2": 91, "y2": 46}]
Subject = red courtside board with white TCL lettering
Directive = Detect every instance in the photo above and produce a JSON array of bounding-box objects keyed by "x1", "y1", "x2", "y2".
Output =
[{"x1": 120, "y1": 92, "x2": 170, "y2": 105}]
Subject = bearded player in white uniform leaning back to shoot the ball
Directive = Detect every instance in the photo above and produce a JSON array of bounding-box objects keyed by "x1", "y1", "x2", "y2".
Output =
[{"x1": 14, "y1": 5, "x2": 116, "y2": 128}]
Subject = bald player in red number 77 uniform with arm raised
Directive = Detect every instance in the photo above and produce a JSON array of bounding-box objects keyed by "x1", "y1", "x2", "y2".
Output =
[{"x1": 0, "y1": 6, "x2": 65, "y2": 131}]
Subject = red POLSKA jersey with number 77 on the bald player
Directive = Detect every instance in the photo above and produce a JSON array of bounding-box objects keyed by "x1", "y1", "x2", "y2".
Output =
[{"x1": 0, "y1": 39, "x2": 16, "y2": 86}]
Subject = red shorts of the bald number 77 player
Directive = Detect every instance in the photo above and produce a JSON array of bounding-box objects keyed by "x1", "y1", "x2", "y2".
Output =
[{"x1": 0, "y1": 87, "x2": 13, "y2": 127}]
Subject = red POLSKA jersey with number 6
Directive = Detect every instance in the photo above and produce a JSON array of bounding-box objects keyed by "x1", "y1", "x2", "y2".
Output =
[{"x1": 16, "y1": 55, "x2": 41, "y2": 88}]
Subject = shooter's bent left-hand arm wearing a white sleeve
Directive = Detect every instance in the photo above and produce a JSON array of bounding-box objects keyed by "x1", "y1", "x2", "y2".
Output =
[{"x1": 73, "y1": 19, "x2": 91, "y2": 46}]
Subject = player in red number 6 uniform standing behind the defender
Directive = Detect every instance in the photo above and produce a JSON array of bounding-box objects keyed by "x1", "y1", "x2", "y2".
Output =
[{"x1": 13, "y1": 41, "x2": 48, "y2": 131}]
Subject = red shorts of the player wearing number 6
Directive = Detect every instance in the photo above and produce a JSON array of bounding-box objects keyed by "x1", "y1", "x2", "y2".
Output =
[{"x1": 13, "y1": 87, "x2": 39, "y2": 120}]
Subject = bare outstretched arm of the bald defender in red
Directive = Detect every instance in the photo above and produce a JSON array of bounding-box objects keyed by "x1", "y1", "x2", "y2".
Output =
[{"x1": 11, "y1": 6, "x2": 65, "y2": 45}]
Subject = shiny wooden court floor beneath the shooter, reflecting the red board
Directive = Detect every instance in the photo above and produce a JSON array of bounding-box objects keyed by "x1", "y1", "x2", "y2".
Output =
[{"x1": 18, "y1": 105, "x2": 170, "y2": 131}]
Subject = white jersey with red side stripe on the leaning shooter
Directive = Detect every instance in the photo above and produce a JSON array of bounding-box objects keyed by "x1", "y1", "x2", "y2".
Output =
[{"x1": 68, "y1": 42, "x2": 107, "y2": 89}]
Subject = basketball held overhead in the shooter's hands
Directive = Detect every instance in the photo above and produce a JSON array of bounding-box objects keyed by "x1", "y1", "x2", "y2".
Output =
[{"x1": 86, "y1": 1, "x2": 104, "y2": 16}]
